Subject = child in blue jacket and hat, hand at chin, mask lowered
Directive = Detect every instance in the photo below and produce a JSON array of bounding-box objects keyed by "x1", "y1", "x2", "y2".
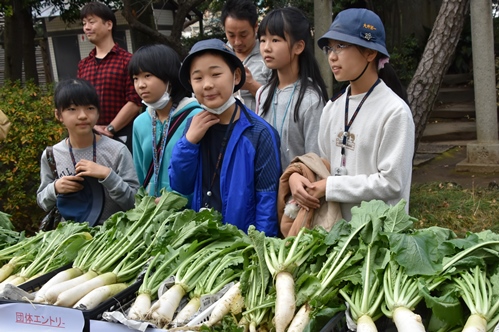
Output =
[{"x1": 169, "y1": 39, "x2": 281, "y2": 236}]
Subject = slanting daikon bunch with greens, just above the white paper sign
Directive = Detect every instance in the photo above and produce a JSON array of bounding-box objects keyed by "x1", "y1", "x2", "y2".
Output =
[{"x1": 35, "y1": 194, "x2": 187, "y2": 310}]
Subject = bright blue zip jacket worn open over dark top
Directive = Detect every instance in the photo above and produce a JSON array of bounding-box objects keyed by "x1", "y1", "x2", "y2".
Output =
[{"x1": 169, "y1": 101, "x2": 281, "y2": 236}]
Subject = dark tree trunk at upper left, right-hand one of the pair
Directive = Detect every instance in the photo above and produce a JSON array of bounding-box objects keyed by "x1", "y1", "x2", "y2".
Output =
[{"x1": 20, "y1": 6, "x2": 39, "y2": 84}]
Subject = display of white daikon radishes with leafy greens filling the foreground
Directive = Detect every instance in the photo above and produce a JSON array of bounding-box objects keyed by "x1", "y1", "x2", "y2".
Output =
[{"x1": 0, "y1": 190, "x2": 499, "y2": 332}]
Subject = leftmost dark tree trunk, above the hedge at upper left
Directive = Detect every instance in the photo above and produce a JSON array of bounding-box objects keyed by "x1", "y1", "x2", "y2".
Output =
[{"x1": 4, "y1": 0, "x2": 23, "y2": 81}]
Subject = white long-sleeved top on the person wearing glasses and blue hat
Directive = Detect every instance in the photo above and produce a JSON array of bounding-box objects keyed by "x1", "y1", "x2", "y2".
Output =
[{"x1": 319, "y1": 81, "x2": 414, "y2": 220}]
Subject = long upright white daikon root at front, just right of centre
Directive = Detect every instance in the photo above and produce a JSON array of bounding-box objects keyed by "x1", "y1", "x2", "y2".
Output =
[{"x1": 275, "y1": 271, "x2": 296, "y2": 332}]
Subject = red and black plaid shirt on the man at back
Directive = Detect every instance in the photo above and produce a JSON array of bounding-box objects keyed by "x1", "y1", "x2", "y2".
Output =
[{"x1": 78, "y1": 44, "x2": 141, "y2": 125}]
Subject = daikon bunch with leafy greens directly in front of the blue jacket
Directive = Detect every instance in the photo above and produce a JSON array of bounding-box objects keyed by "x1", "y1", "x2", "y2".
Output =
[{"x1": 128, "y1": 210, "x2": 248, "y2": 328}]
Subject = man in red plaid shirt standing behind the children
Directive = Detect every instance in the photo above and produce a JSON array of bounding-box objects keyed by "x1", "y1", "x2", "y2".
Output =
[{"x1": 78, "y1": 2, "x2": 141, "y2": 151}]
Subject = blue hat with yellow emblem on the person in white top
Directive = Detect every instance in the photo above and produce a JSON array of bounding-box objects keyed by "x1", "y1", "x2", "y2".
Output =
[{"x1": 317, "y1": 8, "x2": 390, "y2": 57}]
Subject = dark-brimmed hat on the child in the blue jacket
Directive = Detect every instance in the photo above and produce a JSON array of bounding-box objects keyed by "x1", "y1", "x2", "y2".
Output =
[{"x1": 179, "y1": 38, "x2": 246, "y2": 92}]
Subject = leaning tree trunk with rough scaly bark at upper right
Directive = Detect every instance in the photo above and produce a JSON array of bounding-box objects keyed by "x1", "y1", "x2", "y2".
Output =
[{"x1": 407, "y1": 0, "x2": 470, "y2": 151}]
